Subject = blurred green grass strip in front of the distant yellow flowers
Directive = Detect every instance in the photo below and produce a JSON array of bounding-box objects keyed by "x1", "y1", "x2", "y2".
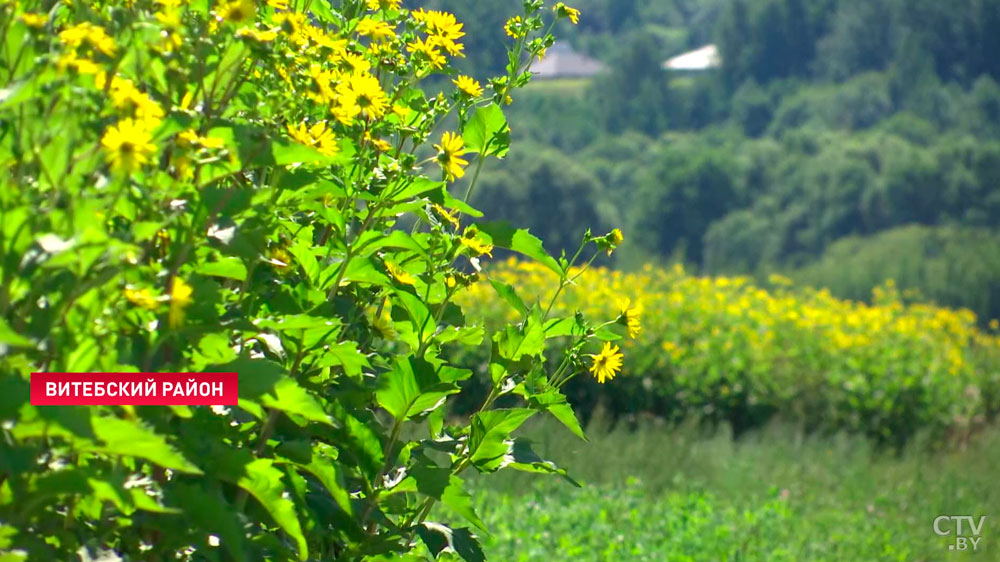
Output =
[{"x1": 437, "y1": 414, "x2": 1000, "y2": 562}]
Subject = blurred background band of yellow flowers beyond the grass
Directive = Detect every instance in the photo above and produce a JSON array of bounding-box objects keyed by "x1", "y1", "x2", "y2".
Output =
[{"x1": 465, "y1": 260, "x2": 1000, "y2": 442}]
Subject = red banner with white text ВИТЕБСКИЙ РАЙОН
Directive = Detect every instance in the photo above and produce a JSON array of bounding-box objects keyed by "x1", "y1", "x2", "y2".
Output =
[{"x1": 31, "y1": 373, "x2": 239, "y2": 406}]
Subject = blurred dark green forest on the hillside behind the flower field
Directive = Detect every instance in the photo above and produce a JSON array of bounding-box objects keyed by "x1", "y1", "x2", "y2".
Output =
[{"x1": 418, "y1": 0, "x2": 1000, "y2": 324}]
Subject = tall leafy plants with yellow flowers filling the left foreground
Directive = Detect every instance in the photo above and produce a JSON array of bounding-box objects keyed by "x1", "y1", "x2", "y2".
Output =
[{"x1": 0, "y1": 0, "x2": 622, "y2": 562}]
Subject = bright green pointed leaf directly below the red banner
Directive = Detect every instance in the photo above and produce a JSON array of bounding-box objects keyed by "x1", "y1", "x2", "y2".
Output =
[{"x1": 85, "y1": 417, "x2": 202, "y2": 474}]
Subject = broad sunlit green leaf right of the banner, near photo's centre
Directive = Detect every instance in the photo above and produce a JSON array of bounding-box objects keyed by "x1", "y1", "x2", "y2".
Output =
[{"x1": 375, "y1": 357, "x2": 459, "y2": 420}]
